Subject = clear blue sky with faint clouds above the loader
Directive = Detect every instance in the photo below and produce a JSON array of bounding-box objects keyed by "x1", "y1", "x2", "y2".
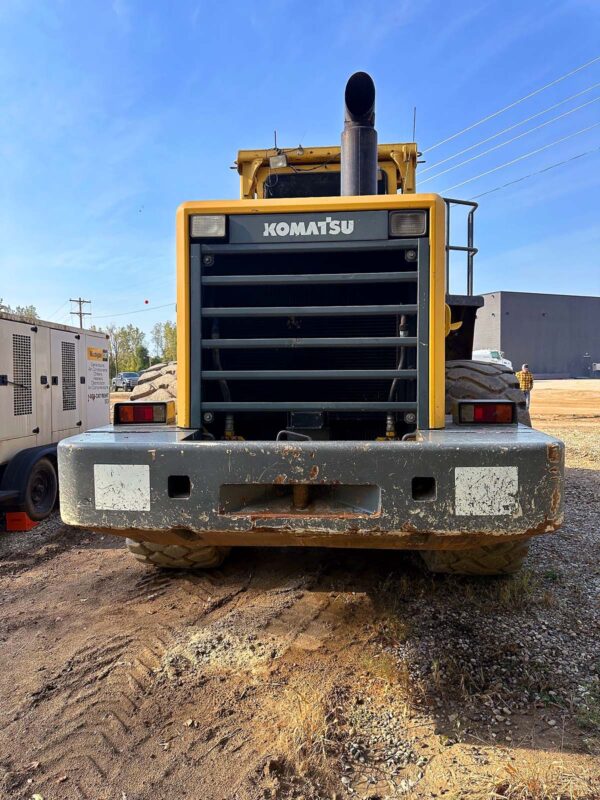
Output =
[{"x1": 0, "y1": 0, "x2": 600, "y2": 340}]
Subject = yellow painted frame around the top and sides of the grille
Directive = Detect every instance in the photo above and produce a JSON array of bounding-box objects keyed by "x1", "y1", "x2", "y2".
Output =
[{"x1": 177, "y1": 192, "x2": 446, "y2": 428}]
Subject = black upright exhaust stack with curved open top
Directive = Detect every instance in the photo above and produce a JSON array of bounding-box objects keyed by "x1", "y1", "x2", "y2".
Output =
[{"x1": 341, "y1": 72, "x2": 377, "y2": 195}]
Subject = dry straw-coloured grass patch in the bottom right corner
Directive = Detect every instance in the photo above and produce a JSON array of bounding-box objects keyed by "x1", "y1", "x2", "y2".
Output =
[{"x1": 488, "y1": 761, "x2": 600, "y2": 800}]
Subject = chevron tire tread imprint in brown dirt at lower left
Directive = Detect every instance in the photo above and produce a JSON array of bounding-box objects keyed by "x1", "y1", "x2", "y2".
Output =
[{"x1": 7, "y1": 624, "x2": 174, "y2": 800}]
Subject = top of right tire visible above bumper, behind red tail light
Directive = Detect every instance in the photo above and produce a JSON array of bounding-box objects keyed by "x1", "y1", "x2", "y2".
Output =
[{"x1": 446, "y1": 361, "x2": 531, "y2": 427}]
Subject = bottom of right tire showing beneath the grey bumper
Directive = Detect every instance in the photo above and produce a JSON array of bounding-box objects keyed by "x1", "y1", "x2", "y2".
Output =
[{"x1": 421, "y1": 539, "x2": 529, "y2": 575}]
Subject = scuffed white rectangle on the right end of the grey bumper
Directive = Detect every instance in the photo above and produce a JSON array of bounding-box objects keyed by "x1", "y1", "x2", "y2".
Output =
[{"x1": 454, "y1": 467, "x2": 519, "y2": 517}]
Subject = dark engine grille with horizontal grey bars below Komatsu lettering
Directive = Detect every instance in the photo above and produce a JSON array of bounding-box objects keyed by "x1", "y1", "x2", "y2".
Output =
[{"x1": 191, "y1": 239, "x2": 429, "y2": 438}]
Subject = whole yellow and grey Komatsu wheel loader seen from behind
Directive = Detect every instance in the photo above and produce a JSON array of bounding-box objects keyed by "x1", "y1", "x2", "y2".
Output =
[{"x1": 59, "y1": 73, "x2": 564, "y2": 574}]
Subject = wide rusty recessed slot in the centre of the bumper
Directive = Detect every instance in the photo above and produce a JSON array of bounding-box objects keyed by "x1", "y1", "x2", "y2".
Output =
[{"x1": 219, "y1": 483, "x2": 381, "y2": 519}]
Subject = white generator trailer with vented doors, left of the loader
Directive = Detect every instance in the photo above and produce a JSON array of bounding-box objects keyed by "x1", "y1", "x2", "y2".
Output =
[{"x1": 0, "y1": 312, "x2": 110, "y2": 521}]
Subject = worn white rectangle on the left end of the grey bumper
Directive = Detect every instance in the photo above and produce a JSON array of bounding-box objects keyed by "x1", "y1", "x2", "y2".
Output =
[{"x1": 94, "y1": 464, "x2": 150, "y2": 511}]
